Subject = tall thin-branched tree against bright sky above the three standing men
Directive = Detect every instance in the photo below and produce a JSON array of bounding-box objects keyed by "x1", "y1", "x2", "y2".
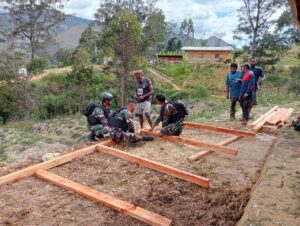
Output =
[{"x1": 234, "y1": 0, "x2": 282, "y2": 56}]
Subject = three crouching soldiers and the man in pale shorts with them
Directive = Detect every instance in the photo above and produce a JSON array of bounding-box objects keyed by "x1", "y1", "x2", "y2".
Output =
[{"x1": 85, "y1": 70, "x2": 187, "y2": 143}]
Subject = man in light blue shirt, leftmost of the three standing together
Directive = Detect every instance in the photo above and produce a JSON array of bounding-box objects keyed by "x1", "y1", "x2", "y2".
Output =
[{"x1": 225, "y1": 63, "x2": 243, "y2": 120}]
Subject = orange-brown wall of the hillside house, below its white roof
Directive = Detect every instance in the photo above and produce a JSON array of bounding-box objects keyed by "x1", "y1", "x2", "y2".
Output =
[{"x1": 184, "y1": 51, "x2": 230, "y2": 63}]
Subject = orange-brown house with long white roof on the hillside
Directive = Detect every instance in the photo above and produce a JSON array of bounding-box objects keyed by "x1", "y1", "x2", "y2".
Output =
[{"x1": 181, "y1": 46, "x2": 233, "y2": 63}]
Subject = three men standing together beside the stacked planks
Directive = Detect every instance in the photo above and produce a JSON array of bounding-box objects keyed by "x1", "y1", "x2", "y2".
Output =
[{"x1": 225, "y1": 58, "x2": 264, "y2": 125}]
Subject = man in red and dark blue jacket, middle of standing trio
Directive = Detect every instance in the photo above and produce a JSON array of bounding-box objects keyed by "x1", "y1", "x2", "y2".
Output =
[{"x1": 240, "y1": 64, "x2": 255, "y2": 125}]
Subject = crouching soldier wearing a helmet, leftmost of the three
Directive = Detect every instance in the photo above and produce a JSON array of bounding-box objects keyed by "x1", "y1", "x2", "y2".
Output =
[{"x1": 88, "y1": 92, "x2": 113, "y2": 141}]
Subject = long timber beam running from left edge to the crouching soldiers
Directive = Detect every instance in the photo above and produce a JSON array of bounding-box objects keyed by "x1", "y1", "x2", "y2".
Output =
[{"x1": 0, "y1": 140, "x2": 116, "y2": 186}]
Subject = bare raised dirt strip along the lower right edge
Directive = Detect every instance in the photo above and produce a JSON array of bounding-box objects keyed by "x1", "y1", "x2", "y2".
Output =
[{"x1": 238, "y1": 128, "x2": 300, "y2": 226}]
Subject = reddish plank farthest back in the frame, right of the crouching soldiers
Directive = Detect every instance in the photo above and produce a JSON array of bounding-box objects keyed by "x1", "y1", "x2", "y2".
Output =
[{"x1": 184, "y1": 122, "x2": 256, "y2": 137}]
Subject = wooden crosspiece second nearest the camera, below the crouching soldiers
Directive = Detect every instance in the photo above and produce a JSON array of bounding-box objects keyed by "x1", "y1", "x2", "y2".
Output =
[{"x1": 96, "y1": 145, "x2": 209, "y2": 188}]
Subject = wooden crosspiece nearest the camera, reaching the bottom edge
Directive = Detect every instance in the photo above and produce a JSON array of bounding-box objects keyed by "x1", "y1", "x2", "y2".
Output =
[{"x1": 35, "y1": 170, "x2": 172, "y2": 226}]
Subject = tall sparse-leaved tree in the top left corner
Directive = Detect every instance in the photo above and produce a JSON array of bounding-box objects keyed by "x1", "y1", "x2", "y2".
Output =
[{"x1": 4, "y1": 0, "x2": 65, "y2": 91}]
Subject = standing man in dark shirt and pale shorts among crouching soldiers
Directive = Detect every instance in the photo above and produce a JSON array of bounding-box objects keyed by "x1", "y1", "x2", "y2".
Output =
[{"x1": 133, "y1": 70, "x2": 153, "y2": 129}]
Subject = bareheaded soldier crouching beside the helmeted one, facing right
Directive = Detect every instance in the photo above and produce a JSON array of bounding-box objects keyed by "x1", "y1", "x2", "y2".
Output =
[{"x1": 108, "y1": 101, "x2": 154, "y2": 143}]
